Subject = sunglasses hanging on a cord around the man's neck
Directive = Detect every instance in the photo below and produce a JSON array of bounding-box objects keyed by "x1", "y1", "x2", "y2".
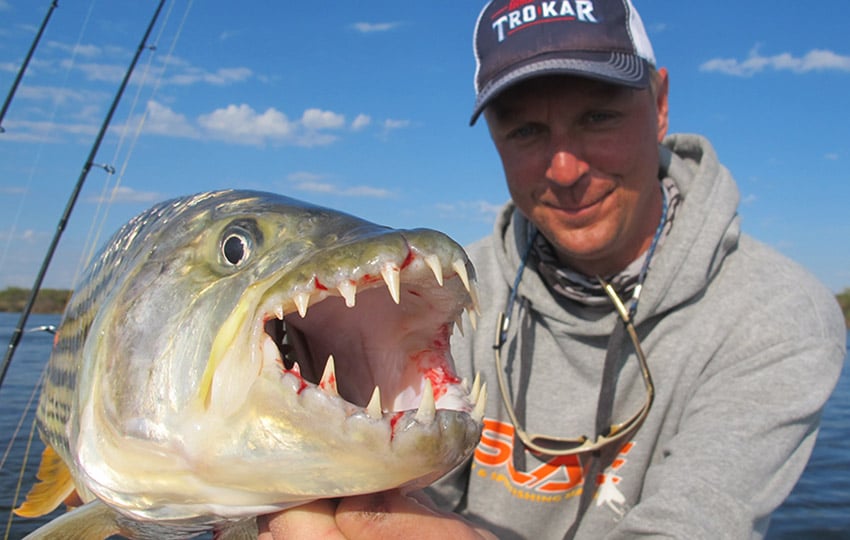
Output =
[{"x1": 493, "y1": 274, "x2": 655, "y2": 456}]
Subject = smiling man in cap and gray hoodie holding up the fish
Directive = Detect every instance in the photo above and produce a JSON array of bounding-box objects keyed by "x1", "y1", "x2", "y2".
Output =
[{"x1": 264, "y1": 0, "x2": 845, "y2": 539}]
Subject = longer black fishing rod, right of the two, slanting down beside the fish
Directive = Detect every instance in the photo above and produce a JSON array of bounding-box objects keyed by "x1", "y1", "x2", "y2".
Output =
[{"x1": 0, "y1": 0, "x2": 165, "y2": 388}]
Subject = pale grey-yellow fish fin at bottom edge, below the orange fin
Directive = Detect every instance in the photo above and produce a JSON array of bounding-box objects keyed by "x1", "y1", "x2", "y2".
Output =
[{"x1": 24, "y1": 501, "x2": 124, "y2": 540}]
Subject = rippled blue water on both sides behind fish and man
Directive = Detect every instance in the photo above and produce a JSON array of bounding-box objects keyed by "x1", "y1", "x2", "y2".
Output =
[{"x1": 0, "y1": 313, "x2": 850, "y2": 540}]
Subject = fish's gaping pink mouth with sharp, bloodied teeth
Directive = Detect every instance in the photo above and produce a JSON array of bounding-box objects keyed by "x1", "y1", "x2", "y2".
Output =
[{"x1": 250, "y1": 231, "x2": 486, "y2": 429}]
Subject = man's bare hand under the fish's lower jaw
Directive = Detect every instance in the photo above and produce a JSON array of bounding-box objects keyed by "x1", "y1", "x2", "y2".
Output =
[{"x1": 259, "y1": 491, "x2": 498, "y2": 540}]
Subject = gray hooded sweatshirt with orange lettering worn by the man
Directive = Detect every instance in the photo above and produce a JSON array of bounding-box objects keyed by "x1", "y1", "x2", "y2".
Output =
[{"x1": 431, "y1": 135, "x2": 846, "y2": 540}]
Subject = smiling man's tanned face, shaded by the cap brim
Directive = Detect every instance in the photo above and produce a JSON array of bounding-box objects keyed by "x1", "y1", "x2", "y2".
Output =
[{"x1": 484, "y1": 69, "x2": 667, "y2": 276}]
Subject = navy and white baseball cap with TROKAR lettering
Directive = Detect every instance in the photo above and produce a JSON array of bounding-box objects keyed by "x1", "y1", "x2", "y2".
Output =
[{"x1": 469, "y1": 0, "x2": 655, "y2": 125}]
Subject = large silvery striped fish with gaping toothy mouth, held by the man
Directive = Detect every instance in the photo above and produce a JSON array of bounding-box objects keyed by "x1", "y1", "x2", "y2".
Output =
[{"x1": 15, "y1": 190, "x2": 487, "y2": 539}]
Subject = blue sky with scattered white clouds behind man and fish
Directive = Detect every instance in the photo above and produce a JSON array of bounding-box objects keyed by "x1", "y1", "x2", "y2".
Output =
[{"x1": 0, "y1": 0, "x2": 850, "y2": 292}]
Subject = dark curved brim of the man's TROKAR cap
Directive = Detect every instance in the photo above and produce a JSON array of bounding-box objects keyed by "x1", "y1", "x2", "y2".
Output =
[{"x1": 469, "y1": 53, "x2": 650, "y2": 126}]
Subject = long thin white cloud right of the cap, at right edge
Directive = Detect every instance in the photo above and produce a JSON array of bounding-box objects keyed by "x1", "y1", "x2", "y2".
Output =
[{"x1": 700, "y1": 47, "x2": 850, "y2": 77}]
